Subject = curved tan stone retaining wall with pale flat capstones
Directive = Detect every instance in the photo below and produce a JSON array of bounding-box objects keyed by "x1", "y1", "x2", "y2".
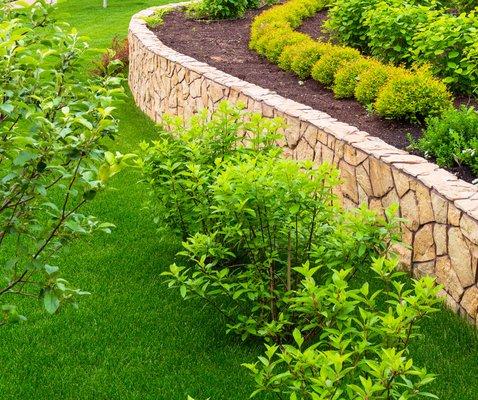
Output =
[{"x1": 129, "y1": 5, "x2": 478, "y2": 324}]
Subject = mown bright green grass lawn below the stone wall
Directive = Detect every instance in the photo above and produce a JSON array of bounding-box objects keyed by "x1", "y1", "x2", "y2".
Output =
[{"x1": 0, "y1": 0, "x2": 478, "y2": 400}]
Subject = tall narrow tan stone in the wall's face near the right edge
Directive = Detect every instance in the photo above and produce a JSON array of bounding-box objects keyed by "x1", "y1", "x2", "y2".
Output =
[{"x1": 448, "y1": 228, "x2": 475, "y2": 287}]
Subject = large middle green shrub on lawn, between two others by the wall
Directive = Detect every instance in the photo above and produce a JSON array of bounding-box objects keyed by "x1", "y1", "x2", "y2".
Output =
[{"x1": 163, "y1": 153, "x2": 402, "y2": 342}]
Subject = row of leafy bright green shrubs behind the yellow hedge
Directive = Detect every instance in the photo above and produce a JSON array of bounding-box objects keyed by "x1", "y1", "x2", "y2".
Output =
[{"x1": 326, "y1": 0, "x2": 478, "y2": 94}]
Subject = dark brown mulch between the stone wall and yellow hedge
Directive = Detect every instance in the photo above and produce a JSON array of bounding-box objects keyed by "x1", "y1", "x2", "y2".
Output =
[{"x1": 154, "y1": 10, "x2": 473, "y2": 181}]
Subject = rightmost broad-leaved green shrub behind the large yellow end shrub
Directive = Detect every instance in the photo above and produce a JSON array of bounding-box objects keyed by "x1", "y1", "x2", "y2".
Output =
[{"x1": 413, "y1": 12, "x2": 478, "y2": 93}]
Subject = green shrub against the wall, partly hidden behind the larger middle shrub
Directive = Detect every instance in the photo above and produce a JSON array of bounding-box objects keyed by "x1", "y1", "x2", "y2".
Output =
[{"x1": 138, "y1": 102, "x2": 282, "y2": 239}]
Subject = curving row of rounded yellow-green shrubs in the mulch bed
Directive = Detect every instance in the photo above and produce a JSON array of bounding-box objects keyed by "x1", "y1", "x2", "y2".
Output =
[{"x1": 249, "y1": 0, "x2": 452, "y2": 121}]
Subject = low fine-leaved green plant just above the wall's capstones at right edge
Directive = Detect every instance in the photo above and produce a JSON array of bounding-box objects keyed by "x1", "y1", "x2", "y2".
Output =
[{"x1": 412, "y1": 107, "x2": 478, "y2": 174}]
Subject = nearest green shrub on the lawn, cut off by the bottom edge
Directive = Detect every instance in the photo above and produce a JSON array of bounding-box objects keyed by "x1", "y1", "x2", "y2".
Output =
[{"x1": 244, "y1": 258, "x2": 439, "y2": 400}]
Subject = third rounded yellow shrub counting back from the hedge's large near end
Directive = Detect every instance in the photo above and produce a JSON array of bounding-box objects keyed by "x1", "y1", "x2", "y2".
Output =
[{"x1": 333, "y1": 58, "x2": 381, "y2": 99}]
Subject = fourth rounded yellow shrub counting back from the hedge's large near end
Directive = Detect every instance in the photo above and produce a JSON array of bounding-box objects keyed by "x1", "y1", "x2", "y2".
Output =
[{"x1": 312, "y1": 47, "x2": 363, "y2": 86}]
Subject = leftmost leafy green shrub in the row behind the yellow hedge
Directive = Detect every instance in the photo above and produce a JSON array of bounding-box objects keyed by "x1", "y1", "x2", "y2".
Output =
[{"x1": 325, "y1": 0, "x2": 380, "y2": 51}]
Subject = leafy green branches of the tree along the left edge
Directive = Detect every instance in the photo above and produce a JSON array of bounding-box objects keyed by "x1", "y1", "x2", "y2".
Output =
[{"x1": 0, "y1": 1, "x2": 130, "y2": 325}]
